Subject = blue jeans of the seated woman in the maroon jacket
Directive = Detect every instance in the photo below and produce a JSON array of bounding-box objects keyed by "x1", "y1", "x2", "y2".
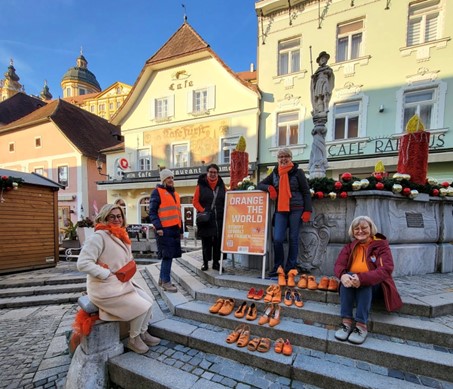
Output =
[{"x1": 340, "y1": 283, "x2": 381, "y2": 324}]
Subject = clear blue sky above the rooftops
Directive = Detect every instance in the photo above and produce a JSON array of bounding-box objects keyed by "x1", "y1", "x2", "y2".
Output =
[{"x1": 0, "y1": 0, "x2": 258, "y2": 98}]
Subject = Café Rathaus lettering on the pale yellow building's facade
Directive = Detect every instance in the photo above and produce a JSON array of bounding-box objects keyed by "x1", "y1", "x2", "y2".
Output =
[{"x1": 327, "y1": 134, "x2": 445, "y2": 158}]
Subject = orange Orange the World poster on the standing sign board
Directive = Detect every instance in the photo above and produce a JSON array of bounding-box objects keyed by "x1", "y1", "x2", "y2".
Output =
[{"x1": 221, "y1": 190, "x2": 269, "y2": 255}]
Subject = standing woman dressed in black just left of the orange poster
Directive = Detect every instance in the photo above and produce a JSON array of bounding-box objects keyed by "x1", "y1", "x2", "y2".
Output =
[{"x1": 192, "y1": 163, "x2": 226, "y2": 271}]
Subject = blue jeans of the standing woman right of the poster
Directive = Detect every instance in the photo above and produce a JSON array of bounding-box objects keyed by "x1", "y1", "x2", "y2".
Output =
[{"x1": 274, "y1": 208, "x2": 303, "y2": 272}]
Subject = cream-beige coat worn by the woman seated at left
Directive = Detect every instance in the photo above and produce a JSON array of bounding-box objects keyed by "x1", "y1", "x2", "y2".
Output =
[{"x1": 77, "y1": 231, "x2": 151, "y2": 321}]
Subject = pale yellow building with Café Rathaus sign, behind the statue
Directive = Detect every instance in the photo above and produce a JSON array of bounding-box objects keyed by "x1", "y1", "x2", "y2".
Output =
[{"x1": 255, "y1": 0, "x2": 453, "y2": 182}]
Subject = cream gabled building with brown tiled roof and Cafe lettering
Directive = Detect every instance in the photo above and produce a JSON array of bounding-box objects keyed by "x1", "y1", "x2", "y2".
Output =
[{"x1": 98, "y1": 22, "x2": 260, "y2": 223}]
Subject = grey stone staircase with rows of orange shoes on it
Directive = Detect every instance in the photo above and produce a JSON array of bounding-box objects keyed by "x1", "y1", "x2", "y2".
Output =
[{"x1": 109, "y1": 251, "x2": 453, "y2": 389}]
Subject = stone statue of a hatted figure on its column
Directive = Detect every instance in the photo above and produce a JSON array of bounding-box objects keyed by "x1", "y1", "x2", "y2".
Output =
[{"x1": 308, "y1": 51, "x2": 335, "y2": 178}]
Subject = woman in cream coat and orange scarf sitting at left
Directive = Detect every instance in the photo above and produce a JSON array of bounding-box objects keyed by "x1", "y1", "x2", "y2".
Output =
[{"x1": 77, "y1": 204, "x2": 160, "y2": 354}]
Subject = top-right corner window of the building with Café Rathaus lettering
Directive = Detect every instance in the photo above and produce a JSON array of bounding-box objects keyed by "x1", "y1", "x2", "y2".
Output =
[{"x1": 407, "y1": 0, "x2": 440, "y2": 46}]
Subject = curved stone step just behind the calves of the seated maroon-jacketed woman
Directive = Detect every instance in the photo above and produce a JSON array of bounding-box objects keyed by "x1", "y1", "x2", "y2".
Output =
[{"x1": 167, "y1": 263, "x2": 453, "y2": 349}]
